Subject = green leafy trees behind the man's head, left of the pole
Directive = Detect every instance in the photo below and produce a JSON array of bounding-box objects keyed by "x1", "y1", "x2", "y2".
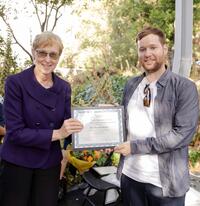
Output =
[{"x1": 107, "y1": 0, "x2": 175, "y2": 68}]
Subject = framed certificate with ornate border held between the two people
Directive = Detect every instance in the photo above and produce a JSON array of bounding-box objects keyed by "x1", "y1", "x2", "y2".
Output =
[{"x1": 72, "y1": 106, "x2": 124, "y2": 149}]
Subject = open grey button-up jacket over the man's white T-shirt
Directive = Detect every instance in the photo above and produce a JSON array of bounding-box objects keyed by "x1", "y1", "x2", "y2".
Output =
[{"x1": 118, "y1": 69, "x2": 199, "y2": 197}]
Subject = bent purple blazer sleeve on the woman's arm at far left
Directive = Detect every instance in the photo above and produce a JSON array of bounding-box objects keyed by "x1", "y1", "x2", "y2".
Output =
[{"x1": 4, "y1": 76, "x2": 53, "y2": 150}]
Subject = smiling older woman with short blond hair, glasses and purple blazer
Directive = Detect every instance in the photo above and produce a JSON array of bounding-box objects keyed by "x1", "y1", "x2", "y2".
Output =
[{"x1": 0, "y1": 32, "x2": 82, "y2": 206}]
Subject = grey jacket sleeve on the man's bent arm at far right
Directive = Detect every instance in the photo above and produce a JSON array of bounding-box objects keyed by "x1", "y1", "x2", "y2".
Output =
[{"x1": 131, "y1": 81, "x2": 199, "y2": 154}]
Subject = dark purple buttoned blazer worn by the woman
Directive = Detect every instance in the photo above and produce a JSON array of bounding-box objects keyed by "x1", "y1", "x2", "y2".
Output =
[{"x1": 1, "y1": 66, "x2": 71, "y2": 169}]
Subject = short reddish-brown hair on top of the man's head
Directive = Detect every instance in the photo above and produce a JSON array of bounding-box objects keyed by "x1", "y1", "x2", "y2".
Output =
[{"x1": 136, "y1": 27, "x2": 166, "y2": 45}]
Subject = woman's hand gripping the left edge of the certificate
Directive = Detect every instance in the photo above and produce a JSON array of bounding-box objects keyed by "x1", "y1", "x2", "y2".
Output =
[{"x1": 52, "y1": 118, "x2": 83, "y2": 141}]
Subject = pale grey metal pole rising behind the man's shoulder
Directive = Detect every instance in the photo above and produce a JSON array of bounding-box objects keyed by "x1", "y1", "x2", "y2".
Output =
[{"x1": 172, "y1": 0, "x2": 193, "y2": 77}]
